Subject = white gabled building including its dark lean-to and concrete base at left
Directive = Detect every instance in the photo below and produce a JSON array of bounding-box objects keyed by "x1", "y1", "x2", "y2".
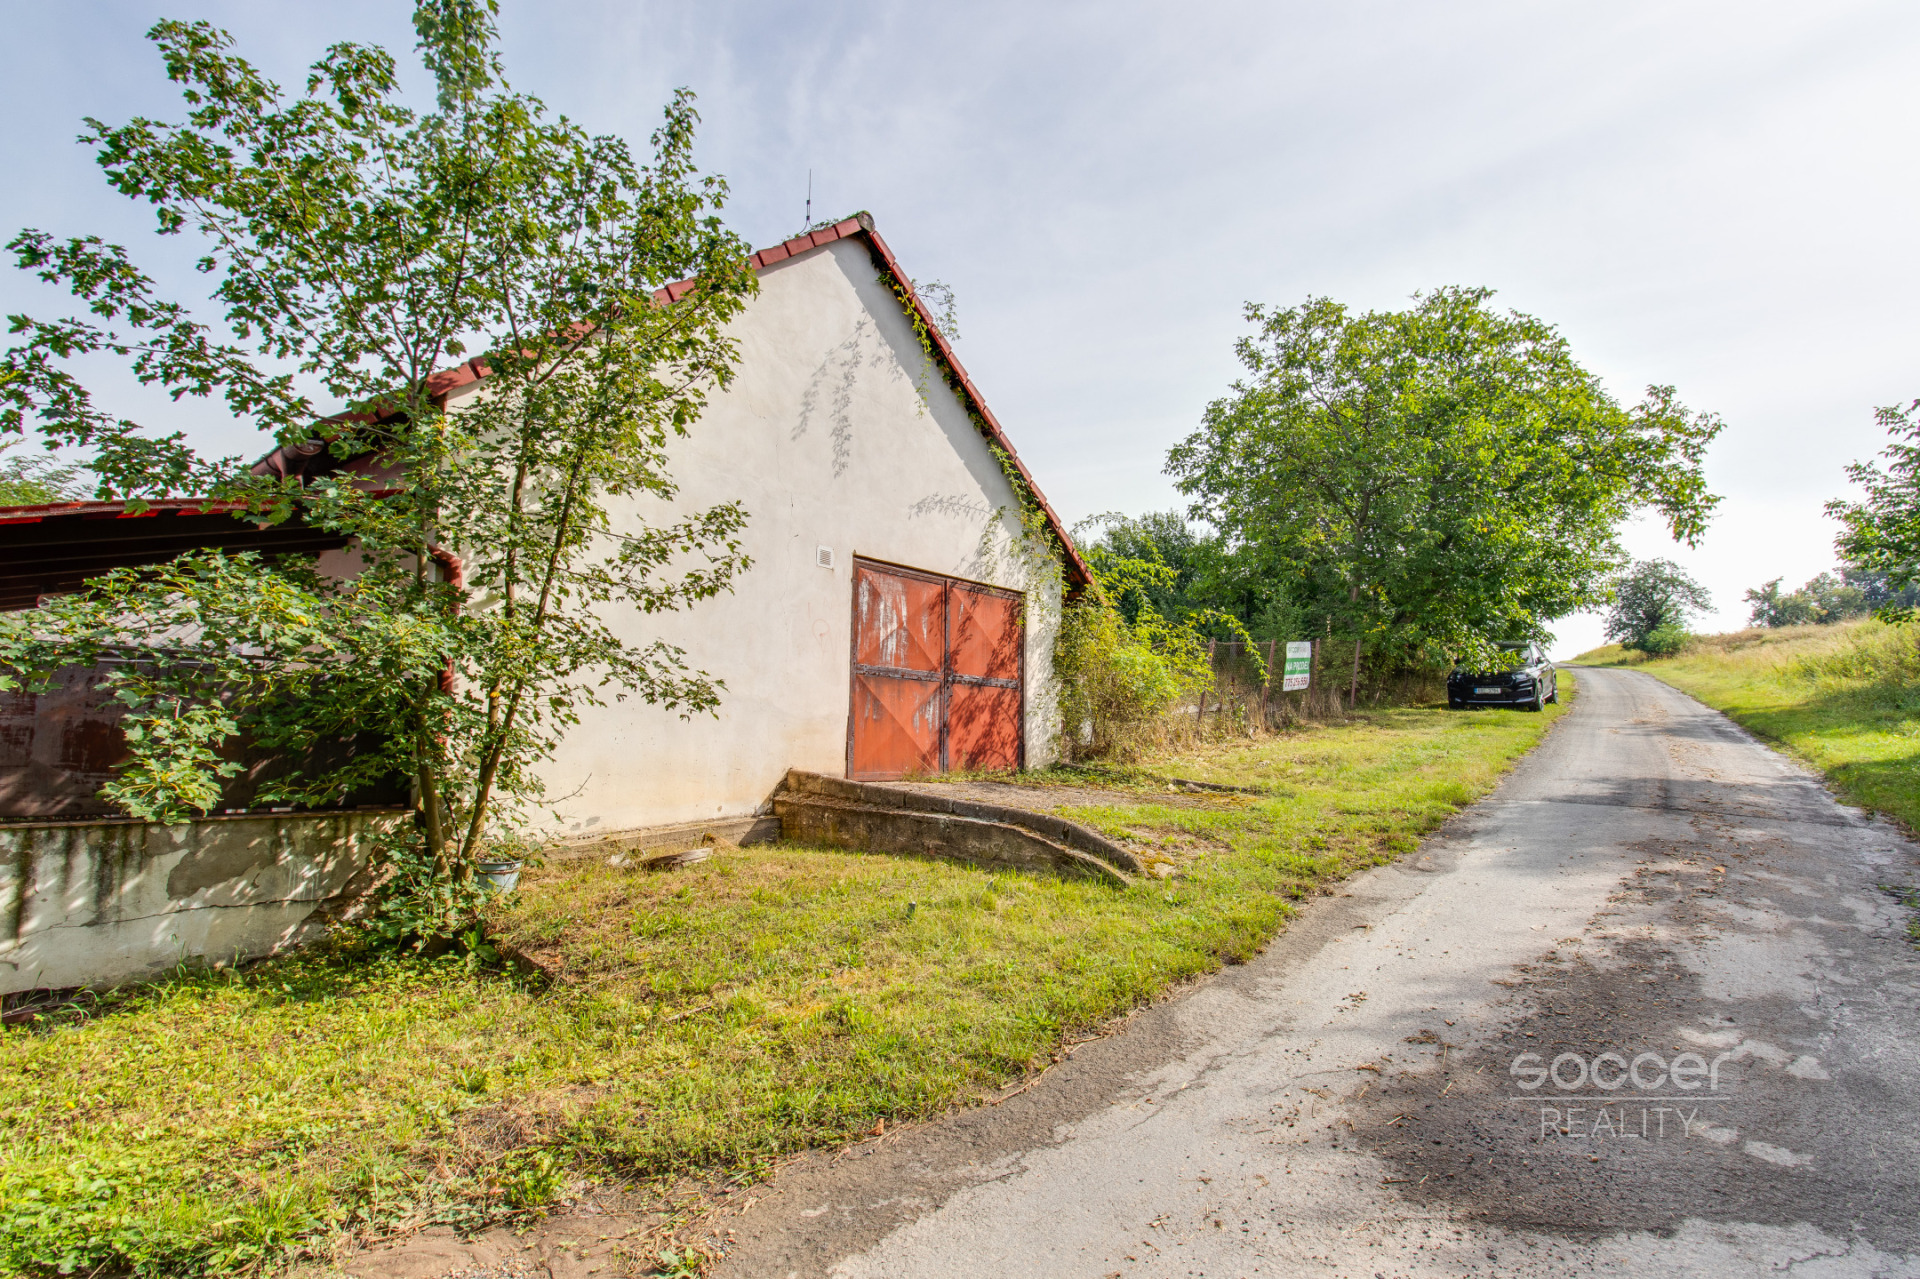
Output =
[{"x1": 0, "y1": 217, "x2": 1087, "y2": 993}]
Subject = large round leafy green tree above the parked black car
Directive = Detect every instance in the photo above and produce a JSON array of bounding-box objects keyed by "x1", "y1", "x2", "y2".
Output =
[{"x1": 1167, "y1": 288, "x2": 1720, "y2": 699}]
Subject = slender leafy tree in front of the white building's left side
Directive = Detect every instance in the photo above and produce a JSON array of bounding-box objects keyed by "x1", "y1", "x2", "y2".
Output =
[{"x1": 0, "y1": 0, "x2": 755, "y2": 931}]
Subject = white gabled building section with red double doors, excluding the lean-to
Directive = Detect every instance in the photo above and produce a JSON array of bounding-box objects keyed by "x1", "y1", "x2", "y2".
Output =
[{"x1": 447, "y1": 215, "x2": 1087, "y2": 837}]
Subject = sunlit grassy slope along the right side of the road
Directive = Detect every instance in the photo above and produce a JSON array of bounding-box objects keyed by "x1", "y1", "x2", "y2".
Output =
[{"x1": 1574, "y1": 622, "x2": 1920, "y2": 830}]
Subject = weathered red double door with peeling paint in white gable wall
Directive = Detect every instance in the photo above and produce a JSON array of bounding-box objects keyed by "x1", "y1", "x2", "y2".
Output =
[{"x1": 847, "y1": 559, "x2": 1025, "y2": 780}]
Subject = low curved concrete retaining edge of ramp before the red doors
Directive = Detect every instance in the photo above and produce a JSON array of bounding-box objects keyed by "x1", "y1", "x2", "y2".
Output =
[{"x1": 774, "y1": 768, "x2": 1140, "y2": 885}]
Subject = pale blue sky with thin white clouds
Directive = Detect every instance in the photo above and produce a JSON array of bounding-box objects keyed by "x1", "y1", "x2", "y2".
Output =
[{"x1": 0, "y1": 0, "x2": 1920, "y2": 657}]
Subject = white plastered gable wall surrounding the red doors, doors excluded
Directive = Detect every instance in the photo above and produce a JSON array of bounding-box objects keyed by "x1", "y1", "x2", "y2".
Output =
[{"x1": 462, "y1": 238, "x2": 1060, "y2": 835}]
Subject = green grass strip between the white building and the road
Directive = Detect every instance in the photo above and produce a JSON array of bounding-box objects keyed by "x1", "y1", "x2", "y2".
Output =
[{"x1": 0, "y1": 684, "x2": 1565, "y2": 1275}]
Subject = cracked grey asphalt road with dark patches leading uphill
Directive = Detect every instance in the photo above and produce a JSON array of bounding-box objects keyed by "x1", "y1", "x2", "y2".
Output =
[{"x1": 716, "y1": 670, "x2": 1920, "y2": 1279}]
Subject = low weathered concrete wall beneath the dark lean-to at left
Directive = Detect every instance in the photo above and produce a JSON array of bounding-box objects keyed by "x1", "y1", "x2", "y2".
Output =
[{"x1": 0, "y1": 812, "x2": 403, "y2": 993}]
